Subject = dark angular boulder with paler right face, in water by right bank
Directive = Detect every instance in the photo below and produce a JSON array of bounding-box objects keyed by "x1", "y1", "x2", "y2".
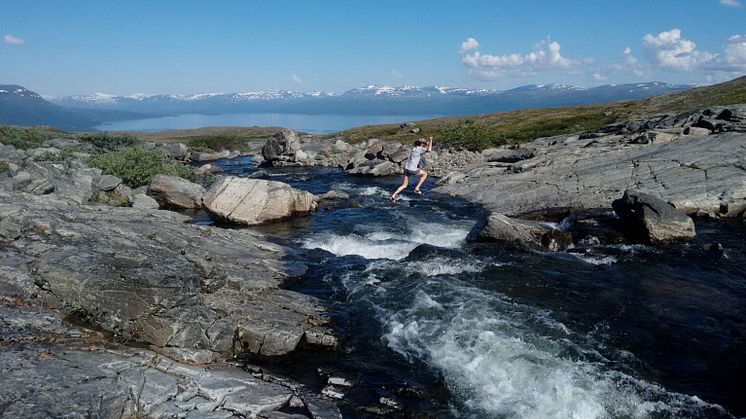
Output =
[{"x1": 611, "y1": 190, "x2": 696, "y2": 244}]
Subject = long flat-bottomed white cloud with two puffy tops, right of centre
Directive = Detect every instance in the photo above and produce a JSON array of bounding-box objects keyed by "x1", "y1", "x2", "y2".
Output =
[{"x1": 461, "y1": 38, "x2": 580, "y2": 80}]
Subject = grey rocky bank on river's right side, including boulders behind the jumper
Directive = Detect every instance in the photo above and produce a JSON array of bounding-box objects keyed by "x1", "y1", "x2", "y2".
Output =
[{"x1": 262, "y1": 105, "x2": 746, "y2": 250}]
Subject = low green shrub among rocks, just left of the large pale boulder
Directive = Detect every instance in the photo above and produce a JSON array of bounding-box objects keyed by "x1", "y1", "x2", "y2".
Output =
[{"x1": 88, "y1": 146, "x2": 193, "y2": 188}]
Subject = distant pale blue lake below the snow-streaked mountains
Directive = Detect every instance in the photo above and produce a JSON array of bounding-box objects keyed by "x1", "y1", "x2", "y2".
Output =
[{"x1": 96, "y1": 113, "x2": 443, "y2": 135}]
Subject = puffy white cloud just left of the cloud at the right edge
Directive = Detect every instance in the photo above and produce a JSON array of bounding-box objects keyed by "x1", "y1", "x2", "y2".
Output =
[{"x1": 642, "y1": 29, "x2": 717, "y2": 71}]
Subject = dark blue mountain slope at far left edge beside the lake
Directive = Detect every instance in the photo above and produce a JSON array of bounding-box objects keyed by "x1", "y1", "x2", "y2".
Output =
[{"x1": 0, "y1": 84, "x2": 147, "y2": 131}]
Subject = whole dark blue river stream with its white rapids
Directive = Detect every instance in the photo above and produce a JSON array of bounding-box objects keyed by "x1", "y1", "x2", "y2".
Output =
[{"x1": 201, "y1": 159, "x2": 746, "y2": 418}]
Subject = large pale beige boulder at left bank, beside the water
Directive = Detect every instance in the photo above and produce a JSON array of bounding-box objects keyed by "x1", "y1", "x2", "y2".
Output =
[{"x1": 204, "y1": 176, "x2": 316, "y2": 225}]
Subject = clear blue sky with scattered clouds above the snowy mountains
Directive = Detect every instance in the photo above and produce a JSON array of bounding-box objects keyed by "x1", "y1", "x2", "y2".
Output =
[{"x1": 0, "y1": 0, "x2": 746, "y2": 96}]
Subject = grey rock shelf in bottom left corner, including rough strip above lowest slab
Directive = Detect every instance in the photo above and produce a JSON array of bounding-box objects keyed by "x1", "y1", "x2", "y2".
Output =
[{"x1": 0, "y1": 304, "x2": 340, "y2": 418}]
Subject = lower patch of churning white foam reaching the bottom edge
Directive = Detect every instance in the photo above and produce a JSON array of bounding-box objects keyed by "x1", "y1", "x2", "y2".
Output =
[{"x1": 381, "y1": 283, "x2": 719, "y2": 418}]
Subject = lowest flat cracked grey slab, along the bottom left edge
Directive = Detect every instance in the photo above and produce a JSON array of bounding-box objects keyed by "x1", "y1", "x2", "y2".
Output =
[{"x1": 0, "y1": 344, "x2": 339, "y2": 418}]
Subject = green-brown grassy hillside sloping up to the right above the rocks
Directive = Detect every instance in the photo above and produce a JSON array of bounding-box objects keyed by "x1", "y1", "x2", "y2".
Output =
[{"x1": 321, "y1": 76, "x2": 746, "y2": 149}]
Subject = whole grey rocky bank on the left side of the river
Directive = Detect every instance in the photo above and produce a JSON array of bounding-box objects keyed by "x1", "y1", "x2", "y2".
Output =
[{"x1": 0, "y1": 140, "x2": 339, "y2": 417}]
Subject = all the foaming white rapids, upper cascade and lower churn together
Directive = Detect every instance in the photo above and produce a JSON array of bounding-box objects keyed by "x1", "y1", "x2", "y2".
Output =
[{"x1": 303, "y1": 208, "x2": 719, "y2": 418}]
